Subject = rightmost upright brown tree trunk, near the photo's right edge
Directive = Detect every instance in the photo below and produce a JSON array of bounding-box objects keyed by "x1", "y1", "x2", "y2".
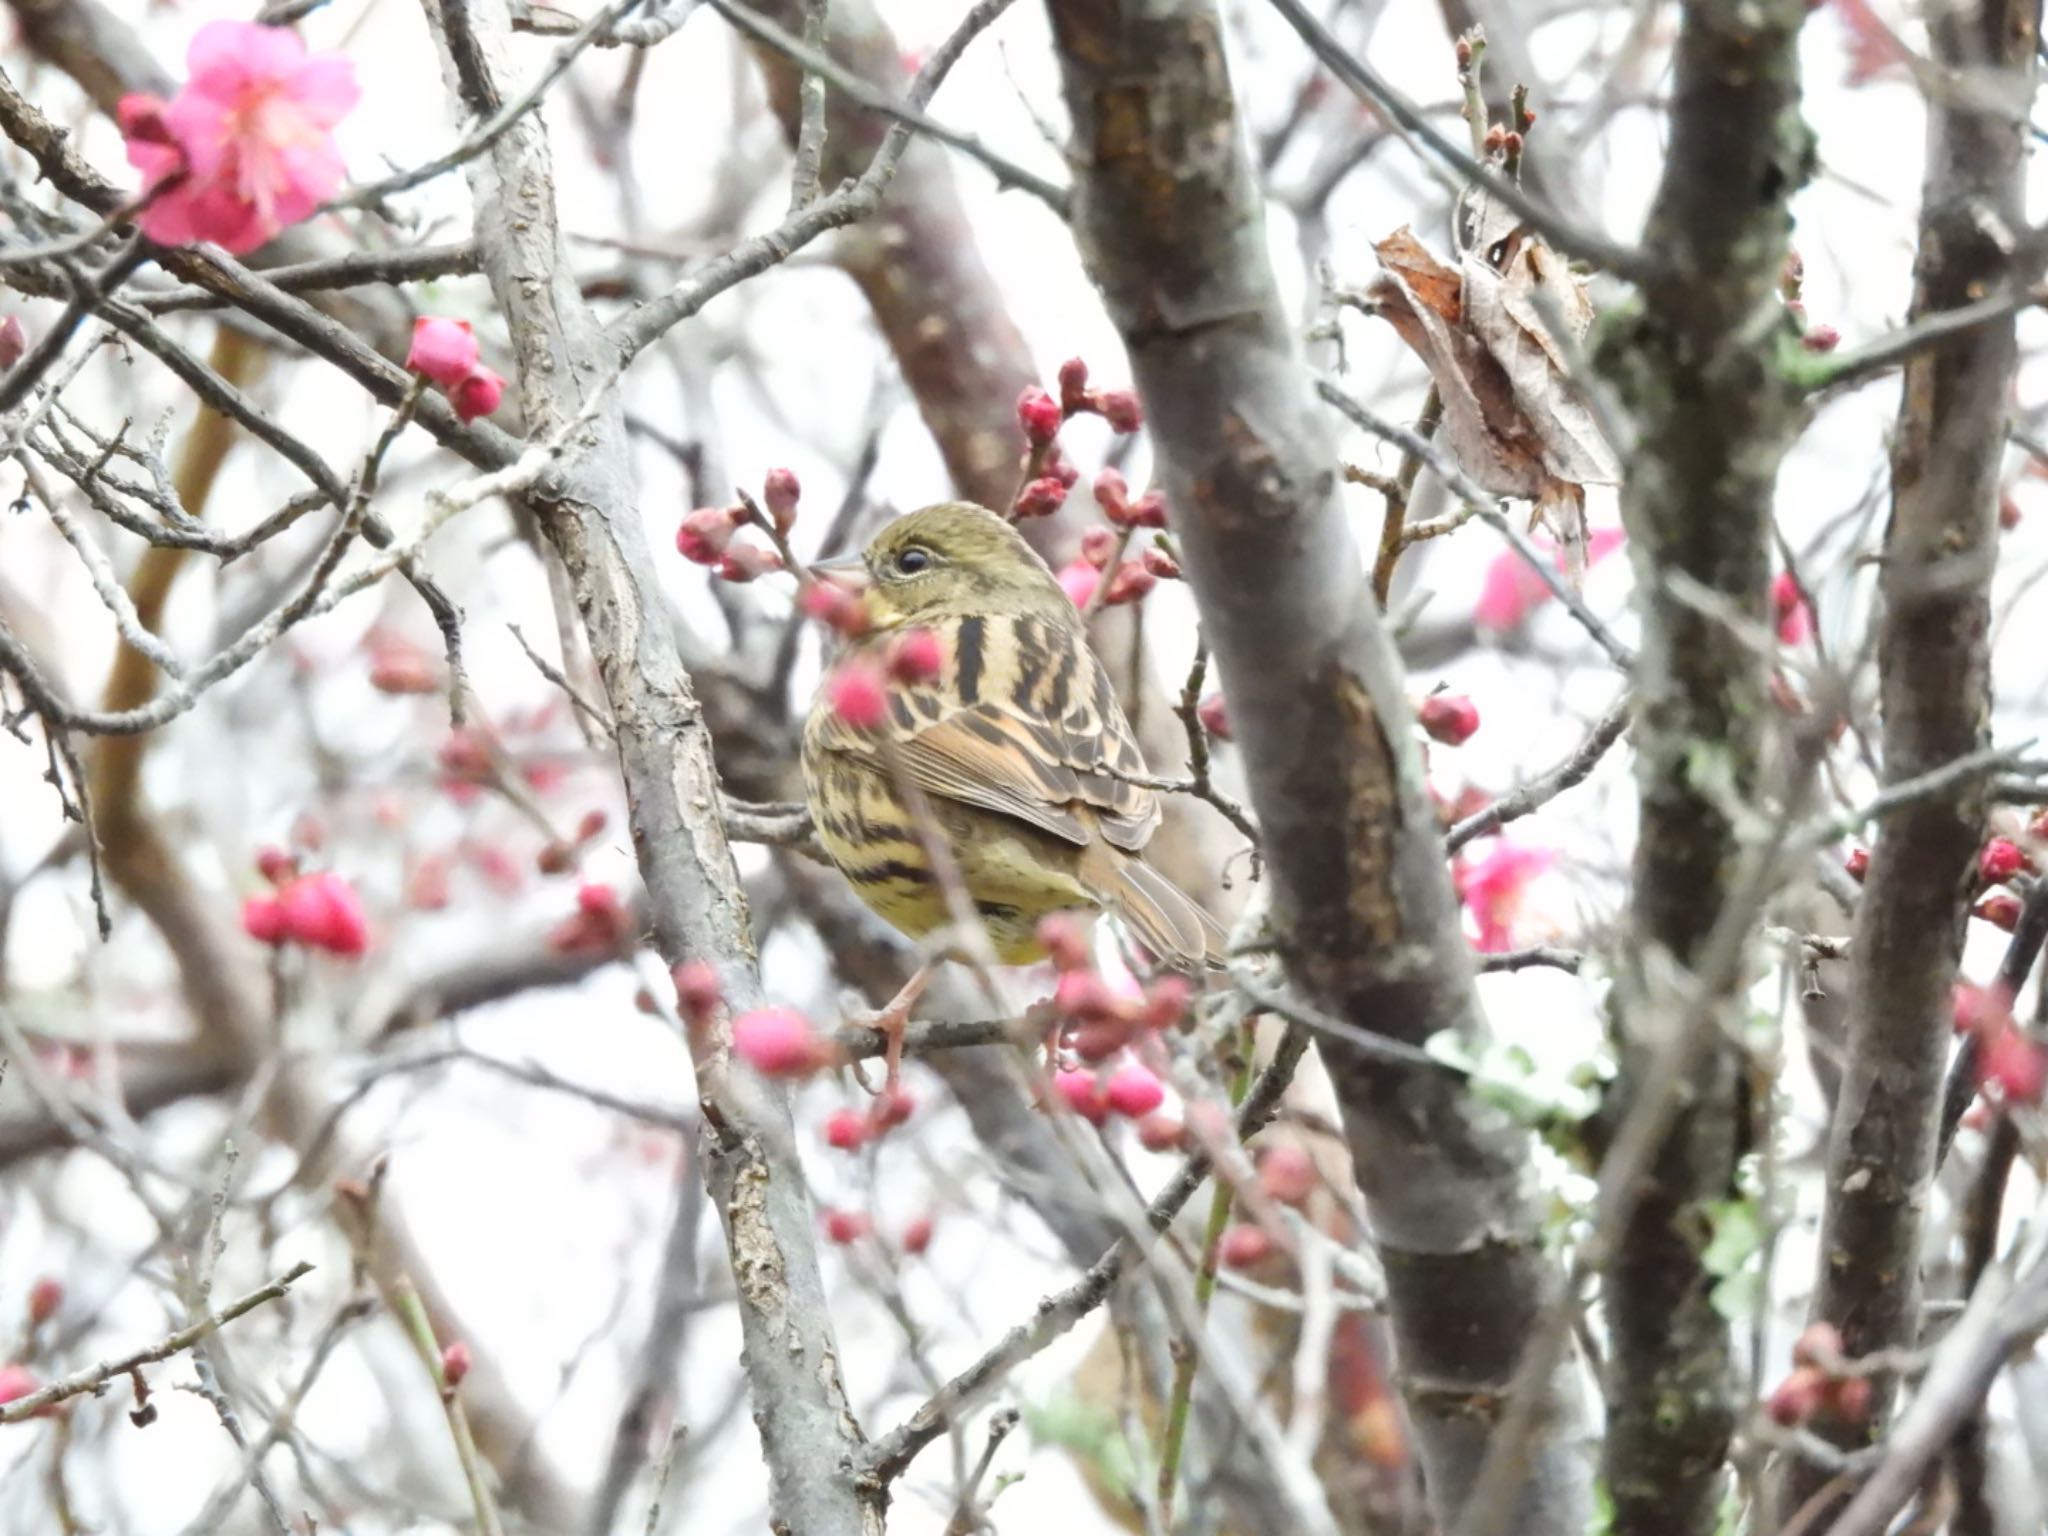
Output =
[{"x1": 1778, "y1": 0, "x2": 2040, "y2": 1511}]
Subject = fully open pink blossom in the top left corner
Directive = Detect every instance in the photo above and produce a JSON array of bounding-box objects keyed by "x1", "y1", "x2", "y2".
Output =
[{"x1": 119, "y1": 20, "x2": 360, "y2": 256}]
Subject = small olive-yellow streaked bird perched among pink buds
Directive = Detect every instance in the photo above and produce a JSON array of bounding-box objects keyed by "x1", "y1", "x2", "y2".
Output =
[{"x1": 803, "y1": 502, "x2": 1223, "y2": 1063}]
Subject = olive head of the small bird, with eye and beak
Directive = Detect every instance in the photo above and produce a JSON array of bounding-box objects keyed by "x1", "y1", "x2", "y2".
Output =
[{"x1": 819, "y1": 502, "x2": 1073, "y2": 631}]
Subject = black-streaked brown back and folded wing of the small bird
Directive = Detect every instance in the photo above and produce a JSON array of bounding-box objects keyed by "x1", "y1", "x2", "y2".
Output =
[{"x1": 817, "y1": 614, "x2": 1159, "y2": 852}]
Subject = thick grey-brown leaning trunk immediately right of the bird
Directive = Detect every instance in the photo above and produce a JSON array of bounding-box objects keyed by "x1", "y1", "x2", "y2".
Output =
[{"x1": 1051, "y1": 0, "x2": 1591, "y2": 1536}]
